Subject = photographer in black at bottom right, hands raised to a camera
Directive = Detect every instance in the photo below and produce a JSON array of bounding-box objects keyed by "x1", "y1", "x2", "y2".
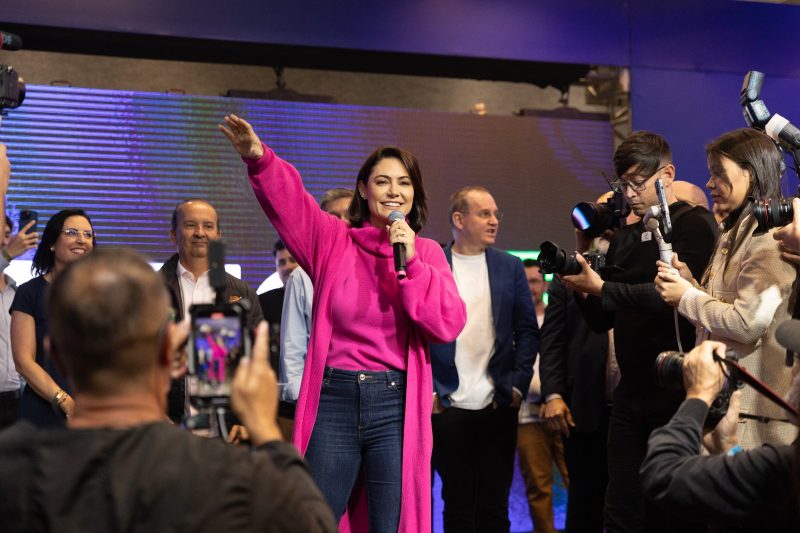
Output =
[{"x1": 641, "y1": 341, "x2": 800, "y2": 532}]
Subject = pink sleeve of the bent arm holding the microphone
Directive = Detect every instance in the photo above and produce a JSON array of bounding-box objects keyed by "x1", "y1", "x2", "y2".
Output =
[{"x1": 399, "y1": 239, "x2": 467, "y2": 343}]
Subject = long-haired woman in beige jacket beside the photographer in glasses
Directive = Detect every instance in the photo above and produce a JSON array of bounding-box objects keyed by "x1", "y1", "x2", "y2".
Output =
[{"x1": 656, "y1": 129, "x2": 797, "y2": 448}]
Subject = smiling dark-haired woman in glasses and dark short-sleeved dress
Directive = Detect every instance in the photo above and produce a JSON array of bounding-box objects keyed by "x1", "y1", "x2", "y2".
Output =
[{"x1": 10, "y1": 209, "x2": 95, "y2": 427}]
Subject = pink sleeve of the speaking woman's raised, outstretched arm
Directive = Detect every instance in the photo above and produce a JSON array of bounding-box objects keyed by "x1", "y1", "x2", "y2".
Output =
[{"x1": 243, "y1": 143, "x2": 347, "y2": 280}]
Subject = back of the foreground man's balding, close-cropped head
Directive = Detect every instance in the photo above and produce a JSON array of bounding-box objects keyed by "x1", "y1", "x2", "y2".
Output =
[{"x1": 48, "y1": 249, "x2": 169, "y2": 395}]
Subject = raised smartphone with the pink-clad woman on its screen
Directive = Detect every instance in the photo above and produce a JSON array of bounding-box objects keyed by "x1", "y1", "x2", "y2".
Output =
[{"x1": 187, "y1": 305, "x2": 251, "y2": 408}]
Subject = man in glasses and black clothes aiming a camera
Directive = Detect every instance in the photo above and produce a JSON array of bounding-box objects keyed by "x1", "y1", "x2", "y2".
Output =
[{"x1": 562, "y1": 131, "x2": 717, "y2": 533}]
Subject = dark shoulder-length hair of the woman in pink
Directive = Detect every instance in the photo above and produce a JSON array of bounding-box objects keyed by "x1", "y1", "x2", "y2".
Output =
[{"x1": 347, "y1": 146, "x2": 428, "y2": 233}]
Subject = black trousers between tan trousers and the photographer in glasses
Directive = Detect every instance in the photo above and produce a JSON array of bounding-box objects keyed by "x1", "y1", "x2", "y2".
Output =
[{"x1": 564, "y1": 405, "x2": 611, "y2": 533}]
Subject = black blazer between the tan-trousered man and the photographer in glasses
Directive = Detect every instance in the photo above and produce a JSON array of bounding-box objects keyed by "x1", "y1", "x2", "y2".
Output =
[{"x1": 539, "y1": 277, "x2": 608, "y2": 432}]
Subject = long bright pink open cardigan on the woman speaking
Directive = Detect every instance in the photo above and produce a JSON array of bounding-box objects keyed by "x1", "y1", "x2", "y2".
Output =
[{"x1": 245, "y1": 146, "x2": 466, "y2": 533}]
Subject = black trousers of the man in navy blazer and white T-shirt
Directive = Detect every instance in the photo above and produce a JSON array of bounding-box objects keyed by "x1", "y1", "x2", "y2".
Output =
[{"x1": 433, "y1": 405, "x2": 519, "y2": 533}]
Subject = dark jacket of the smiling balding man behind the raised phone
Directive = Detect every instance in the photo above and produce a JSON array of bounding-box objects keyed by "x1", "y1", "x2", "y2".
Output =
[{"x1": 160, "y1": 254, "x2": 264, "y2": 422}]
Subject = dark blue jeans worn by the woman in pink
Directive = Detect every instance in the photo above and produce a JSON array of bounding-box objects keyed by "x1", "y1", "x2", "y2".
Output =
[{"x1": 306, "y1": 368, "x2": 406, "y2": 533}]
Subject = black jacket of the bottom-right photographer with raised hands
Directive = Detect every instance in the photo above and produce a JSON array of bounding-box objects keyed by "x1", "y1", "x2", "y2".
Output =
[{"x1": 641, "y1": 399, "x2": 800, "y2": 533}]
